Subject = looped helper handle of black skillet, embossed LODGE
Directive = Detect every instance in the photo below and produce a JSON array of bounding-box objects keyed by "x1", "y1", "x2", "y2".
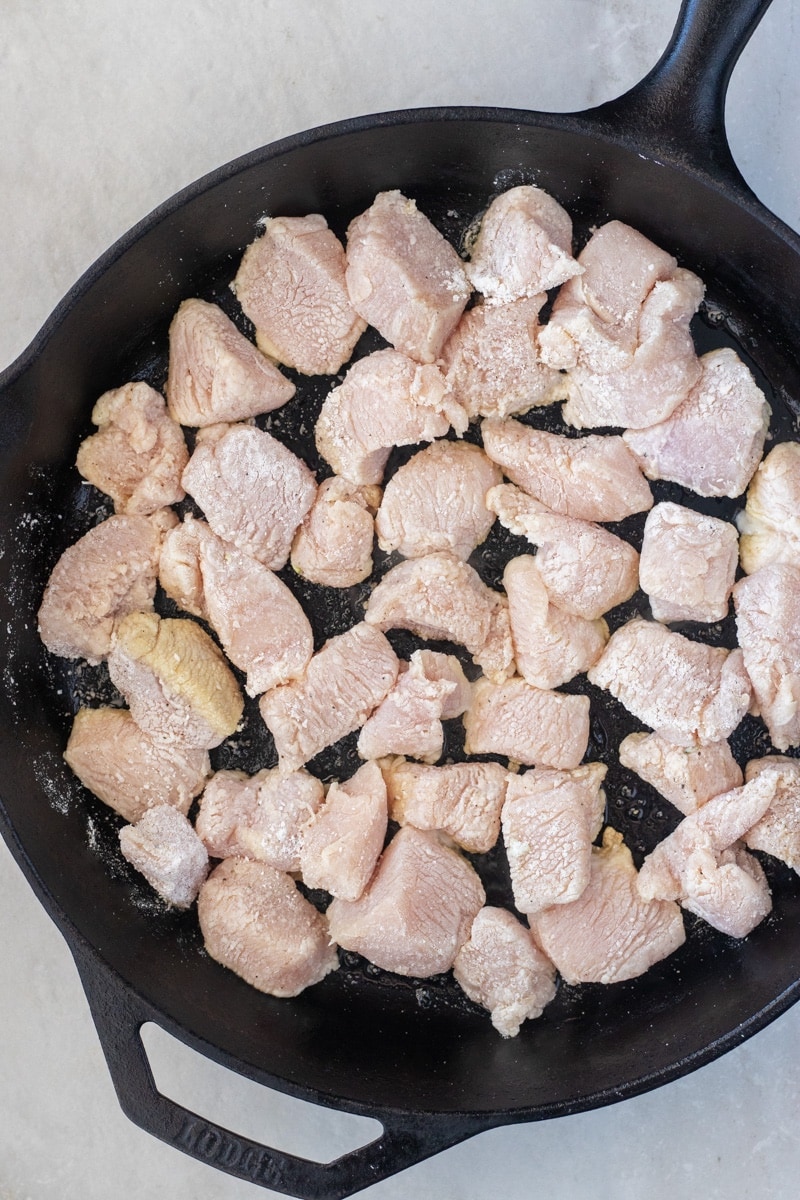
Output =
[{"x1": 71, "y1": 941, "x2": 498, "y2": 1200}]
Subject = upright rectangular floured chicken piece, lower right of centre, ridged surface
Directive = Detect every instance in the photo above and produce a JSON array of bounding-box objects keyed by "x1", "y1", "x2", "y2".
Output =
[{"x1": 501, "y1": 762, "x2": 608, "y2": 913}]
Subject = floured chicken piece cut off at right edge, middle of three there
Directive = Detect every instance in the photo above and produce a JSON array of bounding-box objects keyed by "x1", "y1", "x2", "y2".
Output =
[{"x1": 733, "y1": 563, "x2": 800, "y2": 750}]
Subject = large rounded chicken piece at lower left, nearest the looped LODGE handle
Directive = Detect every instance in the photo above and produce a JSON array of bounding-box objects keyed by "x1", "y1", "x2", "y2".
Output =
[{"x1": 197, "y1": 858, "x2": 338, "y2": 997}]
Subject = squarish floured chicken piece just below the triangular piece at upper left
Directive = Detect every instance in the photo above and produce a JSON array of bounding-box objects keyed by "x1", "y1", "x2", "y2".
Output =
[{"x1": 184, "y1": 425, "x2": 317, "y2": 571}]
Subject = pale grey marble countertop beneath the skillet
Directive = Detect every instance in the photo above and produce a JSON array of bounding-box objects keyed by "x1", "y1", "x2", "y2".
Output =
[{"x1": 0, "y1": 0, "x2": 800, "y2": 1200}]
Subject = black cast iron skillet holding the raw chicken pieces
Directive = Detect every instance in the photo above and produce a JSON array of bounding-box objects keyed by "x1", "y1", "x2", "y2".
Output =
[{"x1": 0, "y1": 0, "x2": 800, "y2": 1198}]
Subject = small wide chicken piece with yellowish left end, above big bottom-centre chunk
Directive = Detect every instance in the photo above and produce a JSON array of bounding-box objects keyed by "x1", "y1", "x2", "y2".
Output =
[{"x1": 381, "y1": 758, "x2": 509, "y2": 854}]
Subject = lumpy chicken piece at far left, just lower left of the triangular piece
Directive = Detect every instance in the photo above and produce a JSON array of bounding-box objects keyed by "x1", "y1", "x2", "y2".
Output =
[{"x1": 76, "y1": 383, "x2": 188, "y2": 516}]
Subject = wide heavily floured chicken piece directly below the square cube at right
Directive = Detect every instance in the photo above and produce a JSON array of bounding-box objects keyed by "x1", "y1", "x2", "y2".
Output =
[{"x1": 588, "y1": 617, "x2": 751, "y2": 746}]
